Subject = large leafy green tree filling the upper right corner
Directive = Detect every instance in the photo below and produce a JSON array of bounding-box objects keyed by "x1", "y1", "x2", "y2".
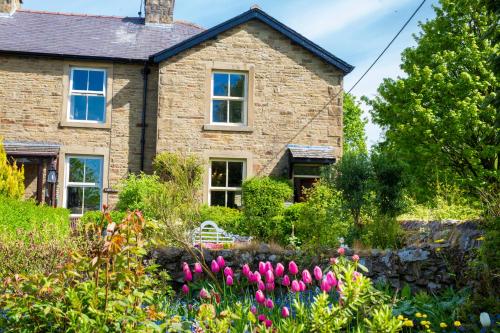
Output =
[{"x1": 366, "y1": 0, "x2": 500, "y2": 196}]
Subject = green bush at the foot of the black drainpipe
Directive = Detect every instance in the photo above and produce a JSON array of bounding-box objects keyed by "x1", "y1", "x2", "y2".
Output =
[{"x1": 116, "y1": 173, "x2": 160, "y2": 216}]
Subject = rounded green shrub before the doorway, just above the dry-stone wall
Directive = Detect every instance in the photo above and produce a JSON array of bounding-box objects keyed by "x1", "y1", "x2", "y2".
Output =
[{"x1": 295, "y1": 182, "x2": 352, "y2": 250}]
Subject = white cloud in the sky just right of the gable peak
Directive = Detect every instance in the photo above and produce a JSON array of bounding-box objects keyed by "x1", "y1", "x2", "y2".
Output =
[{"x1": 287, "y1": 0, "x2": 411, "y2": 39}]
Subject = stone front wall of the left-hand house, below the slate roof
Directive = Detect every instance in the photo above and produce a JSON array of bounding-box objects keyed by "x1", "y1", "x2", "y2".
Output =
[{"x1": 0, "y1": 55, "x2": 158, "y2": 206}]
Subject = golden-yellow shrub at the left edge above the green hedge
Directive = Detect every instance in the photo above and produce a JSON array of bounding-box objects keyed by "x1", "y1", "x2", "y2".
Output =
[{"x1": 0, "y1": 136, "x2": 24, "y2": 199}]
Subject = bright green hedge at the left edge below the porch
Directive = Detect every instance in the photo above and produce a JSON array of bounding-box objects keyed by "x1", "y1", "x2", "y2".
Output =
[{"x1": 0, "y1": 197, "x2": 75, "y2": 280}]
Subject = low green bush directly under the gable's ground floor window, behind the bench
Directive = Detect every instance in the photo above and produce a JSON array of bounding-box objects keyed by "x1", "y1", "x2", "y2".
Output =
[{"x1": 200, "y1": 205, "x2": 248, "y2": 235}]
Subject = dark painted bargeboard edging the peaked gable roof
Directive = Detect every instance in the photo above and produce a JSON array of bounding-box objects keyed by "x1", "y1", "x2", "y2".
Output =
[{"x1": 151, "y1": 8, "x2": 354, "y2": 74}]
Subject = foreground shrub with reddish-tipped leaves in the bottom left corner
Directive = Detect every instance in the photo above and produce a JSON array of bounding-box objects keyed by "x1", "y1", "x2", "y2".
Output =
[{"x1": 0, "y1": 212, "x2": 170, "y2": 333}]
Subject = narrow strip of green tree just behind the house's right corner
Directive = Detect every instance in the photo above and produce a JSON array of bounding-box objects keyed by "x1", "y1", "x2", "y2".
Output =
[{"x1": 344, "y1": 93, "x2": 368, "y2": 154}]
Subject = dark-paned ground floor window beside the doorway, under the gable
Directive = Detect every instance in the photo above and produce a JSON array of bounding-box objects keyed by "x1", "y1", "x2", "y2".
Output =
[{"x1": 208, "y1": 159, "x2": 246, "y2": 208}]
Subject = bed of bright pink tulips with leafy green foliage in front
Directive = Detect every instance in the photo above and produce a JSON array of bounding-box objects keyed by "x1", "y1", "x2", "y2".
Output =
[{"x1": 164, "y1": 248, "x2": 403, "y2": 332}]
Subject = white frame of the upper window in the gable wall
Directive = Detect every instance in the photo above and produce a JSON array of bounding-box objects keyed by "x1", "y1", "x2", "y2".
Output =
[{"x1": 210, "y1": 71, "x2": 248, "y2": 126}]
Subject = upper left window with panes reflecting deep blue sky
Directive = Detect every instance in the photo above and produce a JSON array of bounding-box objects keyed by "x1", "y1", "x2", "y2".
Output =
[{"x1": 68, "y1": 68, "x2": 106, "y2": 123}]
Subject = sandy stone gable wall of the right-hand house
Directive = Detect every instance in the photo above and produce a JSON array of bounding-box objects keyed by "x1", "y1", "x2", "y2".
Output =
[{"x1": 158, "y1": 21, "x2": 343, "y2": 201}]
